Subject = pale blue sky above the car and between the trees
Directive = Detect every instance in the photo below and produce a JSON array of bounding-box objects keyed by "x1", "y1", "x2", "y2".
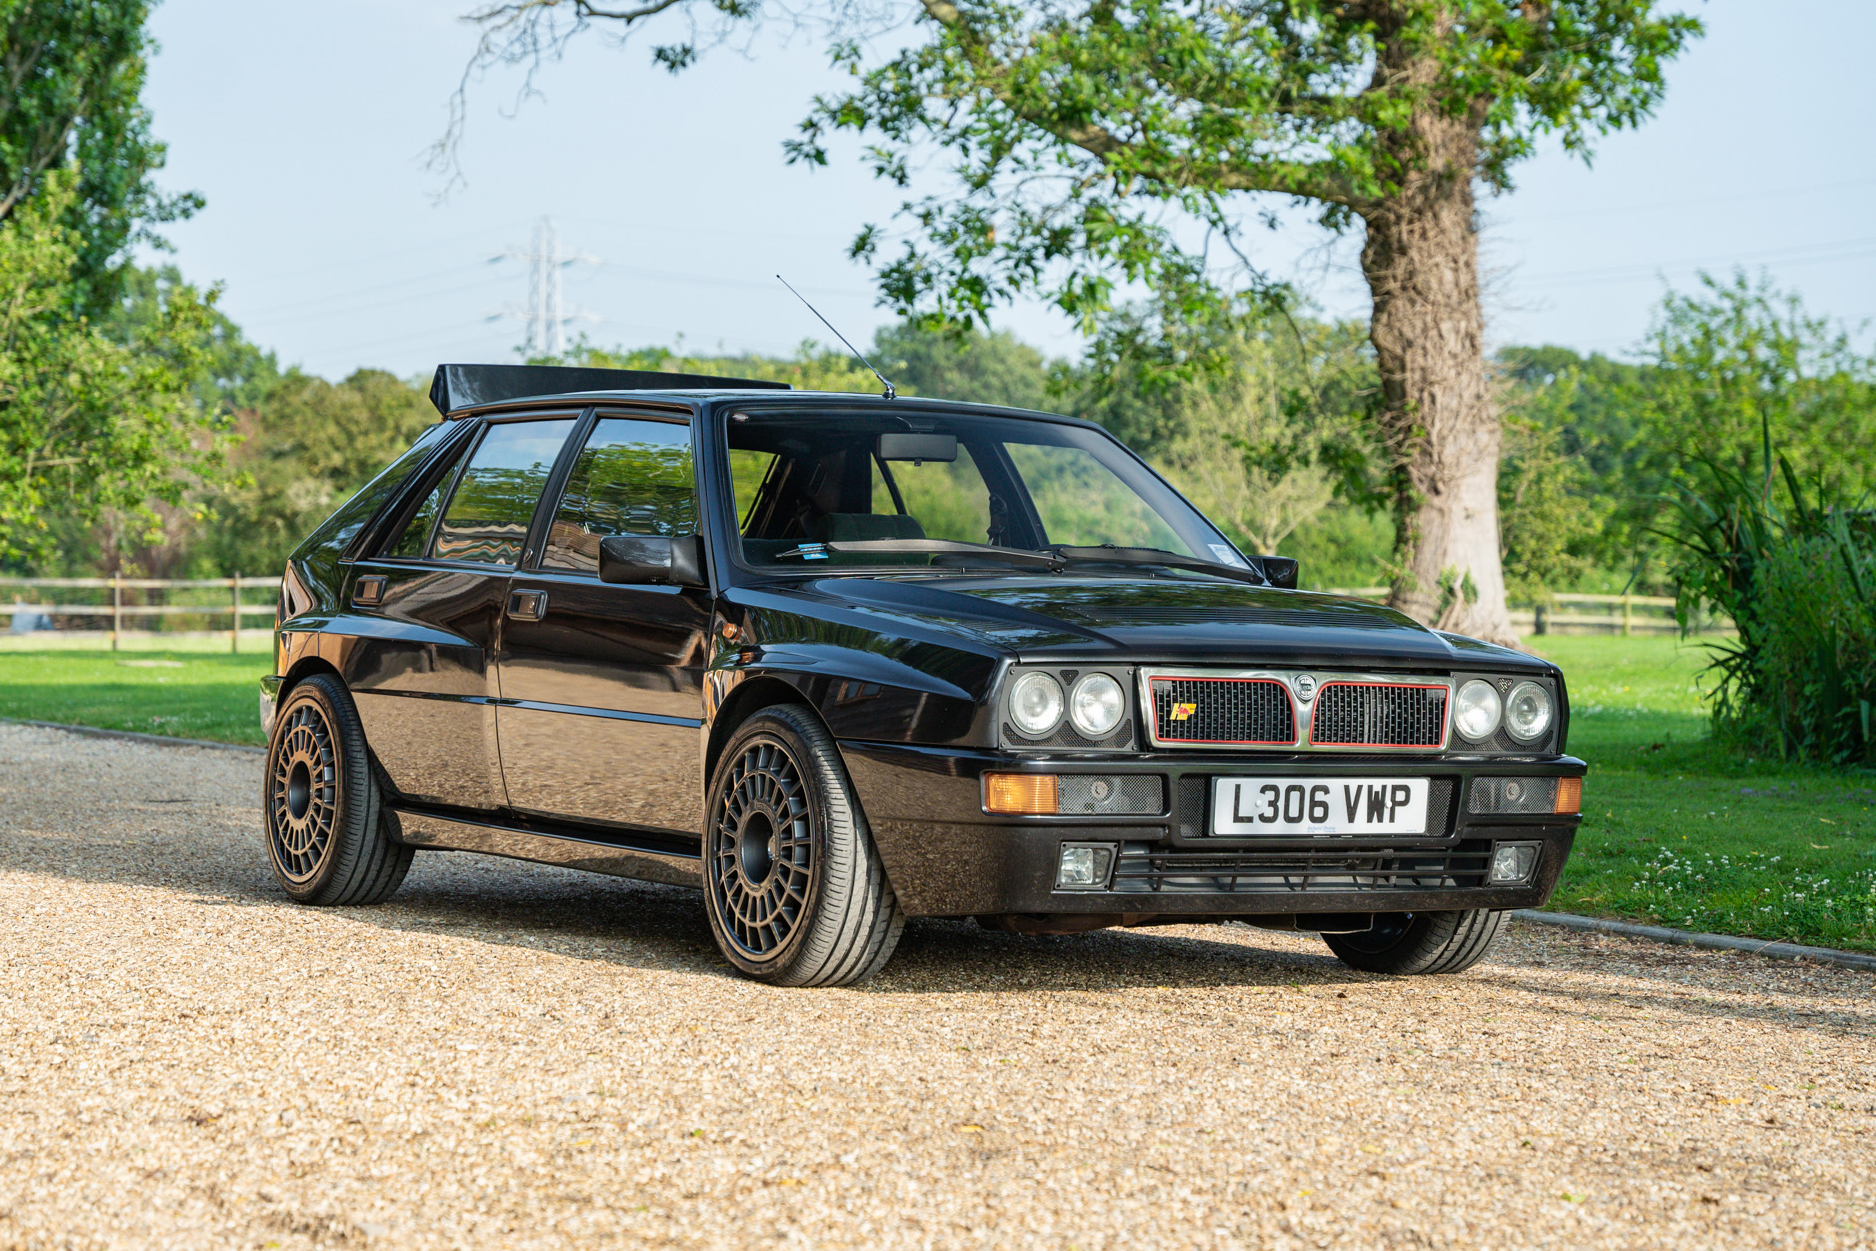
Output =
[{"x1": 148, "y1": 0, "x2": 1876, "y2": 377}]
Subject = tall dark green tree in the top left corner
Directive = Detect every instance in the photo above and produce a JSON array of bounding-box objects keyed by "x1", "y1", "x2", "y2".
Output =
[{"x1": 0, "y1": 0, "x2": 203, "y2": 313}]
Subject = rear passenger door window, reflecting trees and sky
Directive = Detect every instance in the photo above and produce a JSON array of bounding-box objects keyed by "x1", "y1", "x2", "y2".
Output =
[{"x1": 431, "y1": 416, "x2": 574, "y2": 565}]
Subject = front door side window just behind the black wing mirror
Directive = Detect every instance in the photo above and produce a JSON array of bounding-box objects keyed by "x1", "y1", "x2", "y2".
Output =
[{"x1": 540, "y1": 416, "x2": 698, "y2": 574}]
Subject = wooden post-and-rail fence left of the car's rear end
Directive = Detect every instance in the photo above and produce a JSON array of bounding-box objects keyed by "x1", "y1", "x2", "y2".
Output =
[{"x1": 0, "y1": 574, "x2": 280, "y2": 651}]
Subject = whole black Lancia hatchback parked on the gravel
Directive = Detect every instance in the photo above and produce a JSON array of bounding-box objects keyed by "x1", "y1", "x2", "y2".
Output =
[{"x1": 261, "y1": 366, "x2": 1585, "y2": 985}]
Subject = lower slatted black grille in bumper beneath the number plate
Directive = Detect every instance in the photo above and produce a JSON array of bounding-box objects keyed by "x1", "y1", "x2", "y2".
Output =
[{"x1": 1112, "y1": 840, "x2": 1491, "y2": 895}]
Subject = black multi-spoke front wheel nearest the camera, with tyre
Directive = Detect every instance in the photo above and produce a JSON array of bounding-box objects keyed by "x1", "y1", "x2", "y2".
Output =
[{"x1": 704, "y1": 705, "x2": 906, "y2": 987}]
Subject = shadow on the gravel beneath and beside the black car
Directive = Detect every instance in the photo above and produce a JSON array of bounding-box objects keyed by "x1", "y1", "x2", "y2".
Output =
[{"x1": 11, "y1": 825, "x2": 1870, "y2": 1028}]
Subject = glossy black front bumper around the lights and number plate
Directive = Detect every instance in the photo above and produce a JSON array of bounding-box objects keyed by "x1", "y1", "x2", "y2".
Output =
[{"x1": 840, "y1": 743, "x2": 1587, "y2": 928}]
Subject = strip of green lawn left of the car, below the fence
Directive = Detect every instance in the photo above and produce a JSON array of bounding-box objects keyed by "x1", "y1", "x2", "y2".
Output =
[{"x1": 0, "y1": 643, "x2": 274, "y2": 745}]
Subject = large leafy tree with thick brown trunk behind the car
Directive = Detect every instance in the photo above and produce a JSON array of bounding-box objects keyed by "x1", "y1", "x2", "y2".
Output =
[{"x1": 453, "y1": 0, "x2": 1700, "y2": 640}]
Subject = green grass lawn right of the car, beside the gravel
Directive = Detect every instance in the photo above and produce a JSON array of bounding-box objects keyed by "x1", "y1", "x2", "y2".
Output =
[{"x1": 1529, "y1": 636, "x2": 1876, "y2": 951}]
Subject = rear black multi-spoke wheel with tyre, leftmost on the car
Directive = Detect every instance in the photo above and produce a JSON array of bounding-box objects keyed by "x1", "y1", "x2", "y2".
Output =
[{"x1": 261, "y1": 673, "x2": 415, "y2": 904}]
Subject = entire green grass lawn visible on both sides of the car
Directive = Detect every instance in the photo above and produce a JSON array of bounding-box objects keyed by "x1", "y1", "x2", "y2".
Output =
[{"x1": 0, "y1": 636, "x2": 1876, "y2": 951}]
